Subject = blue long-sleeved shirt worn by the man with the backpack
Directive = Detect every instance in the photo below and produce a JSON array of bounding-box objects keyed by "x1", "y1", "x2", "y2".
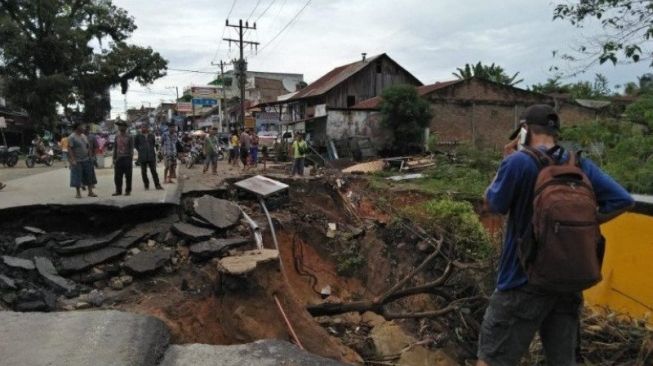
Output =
[{"x1": 486, "y1": 147, "x2": 634, "y2": 290}]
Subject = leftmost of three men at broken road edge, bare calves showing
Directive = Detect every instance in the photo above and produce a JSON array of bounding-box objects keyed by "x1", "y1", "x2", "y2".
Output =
[{"x1": 68, "y1": 122, "x2": 97, "y2": 198}]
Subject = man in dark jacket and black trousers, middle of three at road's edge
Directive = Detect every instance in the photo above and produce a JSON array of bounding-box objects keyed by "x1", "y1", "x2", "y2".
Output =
[{"x1": 112, "y1": 121, "x2": 134, "y2": 196}]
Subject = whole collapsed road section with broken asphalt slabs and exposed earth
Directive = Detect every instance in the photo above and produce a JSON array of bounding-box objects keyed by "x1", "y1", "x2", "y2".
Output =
[{"x1": 0, "y1": 172, "x2": 648, "y2": 366}]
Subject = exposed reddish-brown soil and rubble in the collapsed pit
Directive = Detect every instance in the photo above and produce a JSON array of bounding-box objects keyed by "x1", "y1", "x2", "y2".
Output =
[{"x1": 0, "y1": 172, "x2": 648, "y2": 366}]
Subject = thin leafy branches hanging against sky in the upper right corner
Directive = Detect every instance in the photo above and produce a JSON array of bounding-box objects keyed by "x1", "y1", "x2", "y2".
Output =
[{"x1": 553, "y1": 0, "x2": 653, "y2": 71}]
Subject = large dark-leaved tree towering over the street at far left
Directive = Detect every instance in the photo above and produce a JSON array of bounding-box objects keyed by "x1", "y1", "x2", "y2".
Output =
[{"x1": 0, "y1": 0, "x2": 167, "y2": 126}]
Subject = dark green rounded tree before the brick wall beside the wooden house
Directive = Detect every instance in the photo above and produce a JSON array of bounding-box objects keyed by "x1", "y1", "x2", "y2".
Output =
[{"x1": 380, "y1": 85, "x2": 432, "y2": 153}]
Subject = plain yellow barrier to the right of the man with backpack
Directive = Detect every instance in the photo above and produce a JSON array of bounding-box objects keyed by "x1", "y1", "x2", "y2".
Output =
[{"x1": 584, "y1": 212, "x2": 653, "y2": 324}]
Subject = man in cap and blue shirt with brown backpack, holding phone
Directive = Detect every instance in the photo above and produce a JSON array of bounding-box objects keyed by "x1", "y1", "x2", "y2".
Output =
[{"x1": 477, "y1": 105, "x2": 634, "y2": 366}]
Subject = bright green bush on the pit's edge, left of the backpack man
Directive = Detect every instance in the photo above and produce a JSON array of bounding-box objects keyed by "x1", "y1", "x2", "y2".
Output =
[{"x1": 404, "y1": 198, "x2": 493, "y2": 259}]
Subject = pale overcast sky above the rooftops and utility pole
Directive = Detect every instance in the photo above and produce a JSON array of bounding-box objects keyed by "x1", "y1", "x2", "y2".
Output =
[{"x1": 111, "y1": 0, "x2": 648, "y2": 117}]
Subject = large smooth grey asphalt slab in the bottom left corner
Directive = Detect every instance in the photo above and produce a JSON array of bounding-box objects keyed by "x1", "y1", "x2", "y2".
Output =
[{"x1": 0, "y1": 311, "x2": 170, "y2": 366}]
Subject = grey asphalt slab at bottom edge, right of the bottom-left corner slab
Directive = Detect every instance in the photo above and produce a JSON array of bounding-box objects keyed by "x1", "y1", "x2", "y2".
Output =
[{"x1": 161, "y1": 339, "x2": 344, "y2": 366}]
